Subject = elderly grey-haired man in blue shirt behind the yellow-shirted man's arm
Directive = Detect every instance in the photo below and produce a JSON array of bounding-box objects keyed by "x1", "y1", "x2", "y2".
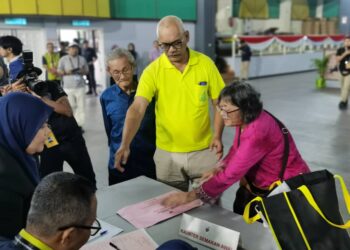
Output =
[{"x1": 100, "y1": 48, "x2": 156, "y2": 185}]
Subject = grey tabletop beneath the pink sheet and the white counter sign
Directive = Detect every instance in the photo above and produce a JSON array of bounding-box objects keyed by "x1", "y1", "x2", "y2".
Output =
[{"x1": 97, "y1": 176, "x2": 277, "y2": 250}]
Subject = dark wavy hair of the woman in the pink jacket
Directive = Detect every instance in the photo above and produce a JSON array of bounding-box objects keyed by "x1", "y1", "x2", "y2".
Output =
[{"x1": 218, "y1": 81, "x2": 263, "y2": 124}]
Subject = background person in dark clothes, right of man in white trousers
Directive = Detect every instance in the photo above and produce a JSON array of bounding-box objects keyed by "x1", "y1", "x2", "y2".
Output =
[{"x1": 82, "y1": 40, "x2": 97, "y2": 96}]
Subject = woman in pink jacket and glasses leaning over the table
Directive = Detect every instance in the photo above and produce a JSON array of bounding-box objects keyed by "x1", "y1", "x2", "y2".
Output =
[{"x1": 163, "y1": 83, "x2": 310, "y2": 213}]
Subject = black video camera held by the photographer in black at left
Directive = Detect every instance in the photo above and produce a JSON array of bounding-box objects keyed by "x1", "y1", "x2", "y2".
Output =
[{"x1": 17, "y1": 50, "x2": 48, "y2": 96}]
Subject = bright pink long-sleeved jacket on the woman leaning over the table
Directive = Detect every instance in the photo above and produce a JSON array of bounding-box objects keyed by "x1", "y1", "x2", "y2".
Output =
[{"x1": 201, "y1": 111, "x2": 310, "y2": 198}]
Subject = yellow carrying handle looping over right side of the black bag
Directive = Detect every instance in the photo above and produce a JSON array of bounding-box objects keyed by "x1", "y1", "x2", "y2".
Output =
[{"x1": 298, "y1": 175, "x2": 350, "y2": 229}]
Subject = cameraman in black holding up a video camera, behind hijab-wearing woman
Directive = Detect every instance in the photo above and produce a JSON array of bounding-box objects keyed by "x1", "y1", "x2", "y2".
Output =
[{"x1": 4, "y1": 51, "x2": 96, "y2": 188}]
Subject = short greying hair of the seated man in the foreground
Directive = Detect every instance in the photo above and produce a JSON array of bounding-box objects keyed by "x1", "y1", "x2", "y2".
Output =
[{"x1": 27, "y1": 172, "x2": 96, "y2": 237}]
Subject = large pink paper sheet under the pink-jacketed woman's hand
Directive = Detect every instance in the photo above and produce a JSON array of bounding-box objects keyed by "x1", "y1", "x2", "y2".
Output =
[{"x1": 117, "y1": 191, "x2": 203, "y2": 228}]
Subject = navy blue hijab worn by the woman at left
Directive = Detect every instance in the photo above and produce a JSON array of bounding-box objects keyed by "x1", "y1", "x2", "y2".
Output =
[{"x1": 0, "y1": 92, "x2": 52, "y2": 183}]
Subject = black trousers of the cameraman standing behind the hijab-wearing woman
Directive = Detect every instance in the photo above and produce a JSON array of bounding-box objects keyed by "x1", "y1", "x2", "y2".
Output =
[{"x1": 40, "y1": 135, "x2": 96, "y2": 185}]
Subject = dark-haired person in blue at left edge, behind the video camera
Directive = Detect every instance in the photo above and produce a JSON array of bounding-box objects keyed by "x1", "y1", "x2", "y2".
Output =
[{"x1": 0, "y1": 36, "x2": 23, "y2": 83}]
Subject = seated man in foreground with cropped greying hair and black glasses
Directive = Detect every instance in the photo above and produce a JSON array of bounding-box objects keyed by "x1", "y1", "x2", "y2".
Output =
[{"x1": 0, "y1": 172, "x2": 97, "y2": 250}]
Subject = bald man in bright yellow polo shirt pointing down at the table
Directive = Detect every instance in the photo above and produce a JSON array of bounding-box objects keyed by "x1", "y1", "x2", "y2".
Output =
[{"x1": 115, "y1": 16, "x2": 224, "y2": 191}]
